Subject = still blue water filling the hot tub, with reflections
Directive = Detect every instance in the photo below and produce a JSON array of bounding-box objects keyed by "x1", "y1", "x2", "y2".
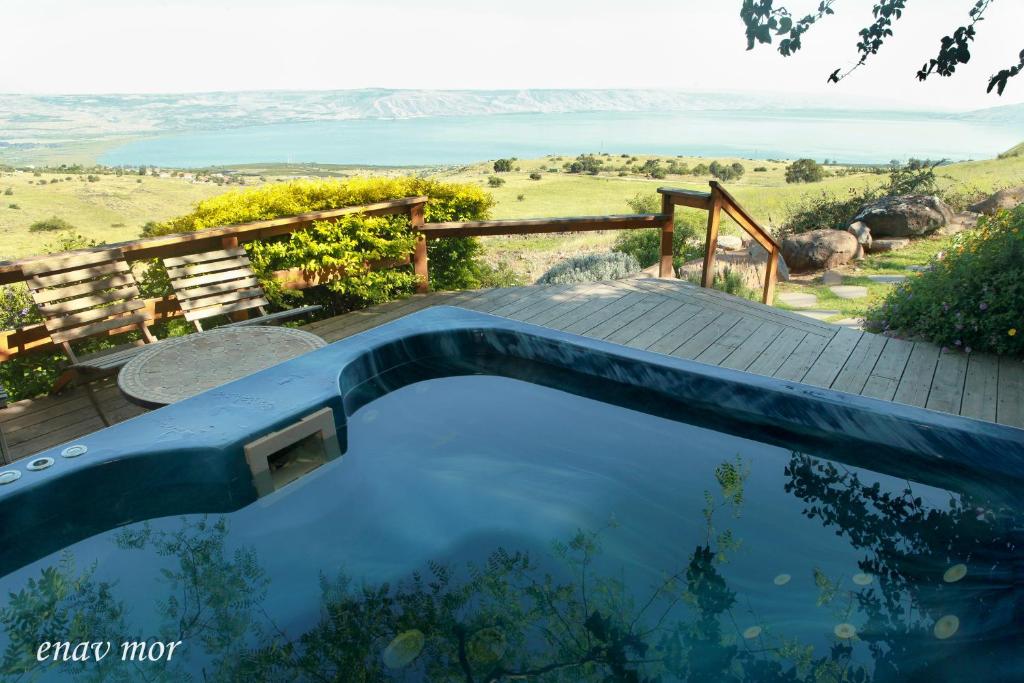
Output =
[{"x1": 0, "y1": 376, "x2": 1024, "y2": 682}]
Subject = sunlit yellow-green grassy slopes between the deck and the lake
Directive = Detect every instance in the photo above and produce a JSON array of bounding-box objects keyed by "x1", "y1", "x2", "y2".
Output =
[{"x1": 0, "y1": 150, "x2": 1024, "y2": 292}]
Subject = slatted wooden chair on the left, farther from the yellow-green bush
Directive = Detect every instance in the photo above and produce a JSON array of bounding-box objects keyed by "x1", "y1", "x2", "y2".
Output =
[{"x1": 22, "y1": 249, "x2": 157, "y2": 425}]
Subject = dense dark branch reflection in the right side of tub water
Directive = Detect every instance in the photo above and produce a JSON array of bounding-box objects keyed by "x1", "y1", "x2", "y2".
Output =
[{"x1": 785, "y1": 454, "x2": 1024, "y2": 681}]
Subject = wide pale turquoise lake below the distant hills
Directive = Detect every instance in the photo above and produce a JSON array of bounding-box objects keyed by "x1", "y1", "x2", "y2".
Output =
[{"x1": 99, "y1": 110, "x2": 1024, "y2": 168}]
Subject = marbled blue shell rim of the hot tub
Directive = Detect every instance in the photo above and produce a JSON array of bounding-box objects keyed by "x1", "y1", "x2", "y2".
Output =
[{"x1": 0, "y1": 307, "x2": 1024, "y2": 575}]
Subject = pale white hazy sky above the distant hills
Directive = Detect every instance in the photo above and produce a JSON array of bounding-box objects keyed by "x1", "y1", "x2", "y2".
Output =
[{"x1": 0, "y1": 0, "x2": 1024, "y2": 110}]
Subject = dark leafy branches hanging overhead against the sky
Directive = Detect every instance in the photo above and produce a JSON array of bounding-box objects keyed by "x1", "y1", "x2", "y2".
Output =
[{"x1": 739, "y1": 0, "x2": 1024, "y2": 95}]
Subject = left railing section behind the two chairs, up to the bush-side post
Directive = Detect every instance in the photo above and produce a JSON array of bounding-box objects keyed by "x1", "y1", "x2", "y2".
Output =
[{"x1": 0, "y1": 197, "x2": 427, "y2": 360}]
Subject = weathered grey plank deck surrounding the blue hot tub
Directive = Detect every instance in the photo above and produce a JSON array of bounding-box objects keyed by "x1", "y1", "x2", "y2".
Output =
[{"x1": 0, "y1": 280, "x2": 1024, "y2": 458}]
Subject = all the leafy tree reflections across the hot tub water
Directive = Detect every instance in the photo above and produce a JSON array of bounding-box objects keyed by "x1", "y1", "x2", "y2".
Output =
[{"x1": 0, "y1": 454, "x2": 1010, "y2": 683}]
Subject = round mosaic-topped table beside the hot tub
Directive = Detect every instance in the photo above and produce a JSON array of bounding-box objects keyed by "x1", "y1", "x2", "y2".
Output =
[{"x1": 118, "y1": 326, "x2": 327, "y2": 408}]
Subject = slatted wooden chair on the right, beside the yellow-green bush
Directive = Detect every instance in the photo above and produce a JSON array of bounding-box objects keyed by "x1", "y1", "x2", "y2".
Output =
[{"x1": 164, "y1": 247, "x2": 322, "y2": 332}]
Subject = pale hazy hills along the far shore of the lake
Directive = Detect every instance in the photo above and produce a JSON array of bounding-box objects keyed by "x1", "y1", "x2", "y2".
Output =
[{"x1": 0, "y1": 89, "x2": 962, "y2": 144}]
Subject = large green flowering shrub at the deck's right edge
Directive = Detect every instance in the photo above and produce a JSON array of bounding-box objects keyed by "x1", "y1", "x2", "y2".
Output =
[{"x1": 866, "y1": 206, "x2": 1024, "y2": 355}]
